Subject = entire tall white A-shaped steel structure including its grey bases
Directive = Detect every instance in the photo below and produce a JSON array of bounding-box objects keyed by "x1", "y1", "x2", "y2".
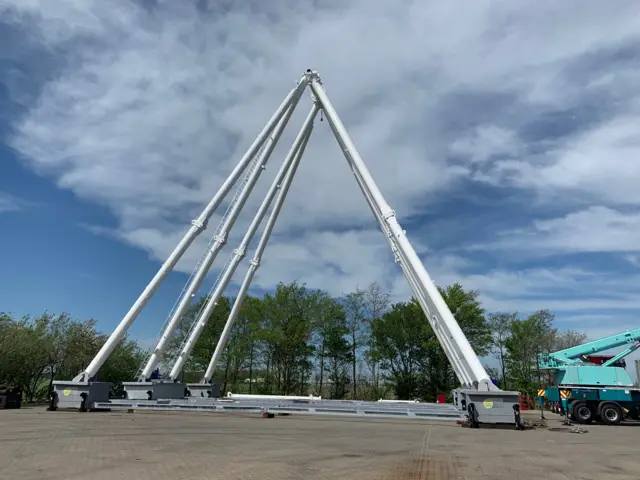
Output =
[{"x1": 51, "y1": 69, "x2": 521, "y2": 428}]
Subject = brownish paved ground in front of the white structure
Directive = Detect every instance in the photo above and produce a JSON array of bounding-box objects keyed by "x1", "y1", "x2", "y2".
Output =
[{"x1": 0, "y1": 408, "x2": 640, "y2": 480}]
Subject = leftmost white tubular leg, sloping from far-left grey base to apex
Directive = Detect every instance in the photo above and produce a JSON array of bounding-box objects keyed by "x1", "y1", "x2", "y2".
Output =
[{"x1": 74, "y1": 80, "x2": 310, "y2": 381}]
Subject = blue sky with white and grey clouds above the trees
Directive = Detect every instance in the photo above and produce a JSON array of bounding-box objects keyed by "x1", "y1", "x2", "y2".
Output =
[{"x1": 0, "y1": 0, "x2": 640, "y2": 376}]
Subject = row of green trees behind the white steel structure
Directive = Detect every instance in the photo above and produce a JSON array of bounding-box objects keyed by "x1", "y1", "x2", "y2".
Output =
[{"x1": 0, "y1": 282, "x2": 586, "y2": 401}]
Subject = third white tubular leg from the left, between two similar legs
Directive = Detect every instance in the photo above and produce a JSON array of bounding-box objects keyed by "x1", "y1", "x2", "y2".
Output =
[{"x1": 169, "y1": 104, "x2": 318, "y2": 380}]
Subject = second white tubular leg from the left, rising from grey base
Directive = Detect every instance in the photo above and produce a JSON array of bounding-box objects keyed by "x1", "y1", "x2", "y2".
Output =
[{"x1": 139, "y1": 101, "x2": 302, "y2": 381}]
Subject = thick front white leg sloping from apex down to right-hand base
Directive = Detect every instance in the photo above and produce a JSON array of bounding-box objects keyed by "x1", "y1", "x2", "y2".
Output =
[{"x1": 311, "y1": 75, "x2": 491, "y2": 385}]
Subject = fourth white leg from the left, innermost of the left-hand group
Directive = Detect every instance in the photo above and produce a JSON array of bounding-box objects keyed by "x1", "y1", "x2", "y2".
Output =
[{"x1": 200, "y1": 111, "x2": 318, "y2": 383}]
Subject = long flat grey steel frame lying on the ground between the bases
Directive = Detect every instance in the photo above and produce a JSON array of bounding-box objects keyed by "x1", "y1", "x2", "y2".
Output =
[{"x1": 92, "y1": 397, "x2": 462, "y2": 421}]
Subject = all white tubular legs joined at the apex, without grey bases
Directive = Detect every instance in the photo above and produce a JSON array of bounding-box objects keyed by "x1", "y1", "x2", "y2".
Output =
[{"x1": 74, "y1": 70, "x2": 498, "y2": 391}]
